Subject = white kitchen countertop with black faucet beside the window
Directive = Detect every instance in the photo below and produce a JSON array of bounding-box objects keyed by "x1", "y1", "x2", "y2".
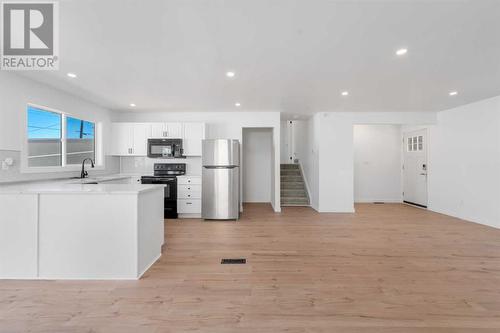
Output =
[{"x1": 0, "y1": 175, "x2": 164, "y2": 194}]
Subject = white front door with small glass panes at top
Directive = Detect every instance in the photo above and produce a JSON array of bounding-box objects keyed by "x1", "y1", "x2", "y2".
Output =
[{"x1": 403, "y1": 129, "x2": 428, "y2": 207}]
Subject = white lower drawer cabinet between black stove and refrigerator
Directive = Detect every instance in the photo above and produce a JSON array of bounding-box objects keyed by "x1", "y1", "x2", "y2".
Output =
[{"x1": 177, "y1": 176, "x2": 201, "y2": 218}]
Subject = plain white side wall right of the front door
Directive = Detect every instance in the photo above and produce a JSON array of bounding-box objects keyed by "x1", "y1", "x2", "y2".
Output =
[{"x1": 428, "y1": 96, "x2": 500, "y2": 228}]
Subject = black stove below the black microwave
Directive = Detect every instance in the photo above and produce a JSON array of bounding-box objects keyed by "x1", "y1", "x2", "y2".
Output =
[{"x1": 141, "y1": 163, "x2": 186, "y2": 219}]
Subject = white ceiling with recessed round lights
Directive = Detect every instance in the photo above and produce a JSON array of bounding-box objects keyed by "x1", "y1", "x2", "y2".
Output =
[{"x1": 17, "y1": 0, "x2": 500, "y2": 115}]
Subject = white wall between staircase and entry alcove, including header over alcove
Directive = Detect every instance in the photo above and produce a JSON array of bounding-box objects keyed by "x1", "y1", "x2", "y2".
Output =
[{"x1": 311, "y1": 112, "x2": 436, "y2": 212}]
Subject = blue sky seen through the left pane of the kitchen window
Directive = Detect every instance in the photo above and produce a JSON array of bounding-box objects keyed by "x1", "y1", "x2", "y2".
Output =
[{"x1": 28, "y1": 106, "x2": 61, "y2": 139}]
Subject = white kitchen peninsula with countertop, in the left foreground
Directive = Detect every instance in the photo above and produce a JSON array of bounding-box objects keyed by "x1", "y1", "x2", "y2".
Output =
[{"x1": 0, "y1": 183, "x2": 164, "y2": 279}]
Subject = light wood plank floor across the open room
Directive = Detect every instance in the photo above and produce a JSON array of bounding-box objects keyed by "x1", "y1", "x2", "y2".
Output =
[{"x1": 0, "y1": 204, "x2": 500, "y2": 333}]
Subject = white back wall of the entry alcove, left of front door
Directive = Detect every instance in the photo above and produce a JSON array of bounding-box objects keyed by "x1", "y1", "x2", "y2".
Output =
[{"x1": 353, "y1": 125, "x2": 402, "y2": 202}]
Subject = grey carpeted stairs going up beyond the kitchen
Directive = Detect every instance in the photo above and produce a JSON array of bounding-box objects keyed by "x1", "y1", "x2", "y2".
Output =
[{"x1": 280, "y1": 164, "x2": 309, "y2": 206}]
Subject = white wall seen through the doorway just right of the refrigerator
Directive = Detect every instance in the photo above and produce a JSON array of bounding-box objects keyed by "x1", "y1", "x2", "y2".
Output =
[{"x1": 241, "y1": 128, "x2": 273, "y2": 202}]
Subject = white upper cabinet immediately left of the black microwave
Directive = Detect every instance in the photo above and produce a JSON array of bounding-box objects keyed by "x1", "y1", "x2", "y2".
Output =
[{"x1": 111, "y1": 123, "x2": 151, "y2": 156}]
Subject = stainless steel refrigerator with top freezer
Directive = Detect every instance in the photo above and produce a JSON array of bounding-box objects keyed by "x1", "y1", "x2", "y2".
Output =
[{"x1": 201, "y1": 139, "x2": 240, "y2": 220}]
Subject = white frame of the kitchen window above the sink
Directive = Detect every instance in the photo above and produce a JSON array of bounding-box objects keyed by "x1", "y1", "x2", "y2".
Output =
[{"x1": 21, "y1": 103, "x2": 105, "y2": 173}]
